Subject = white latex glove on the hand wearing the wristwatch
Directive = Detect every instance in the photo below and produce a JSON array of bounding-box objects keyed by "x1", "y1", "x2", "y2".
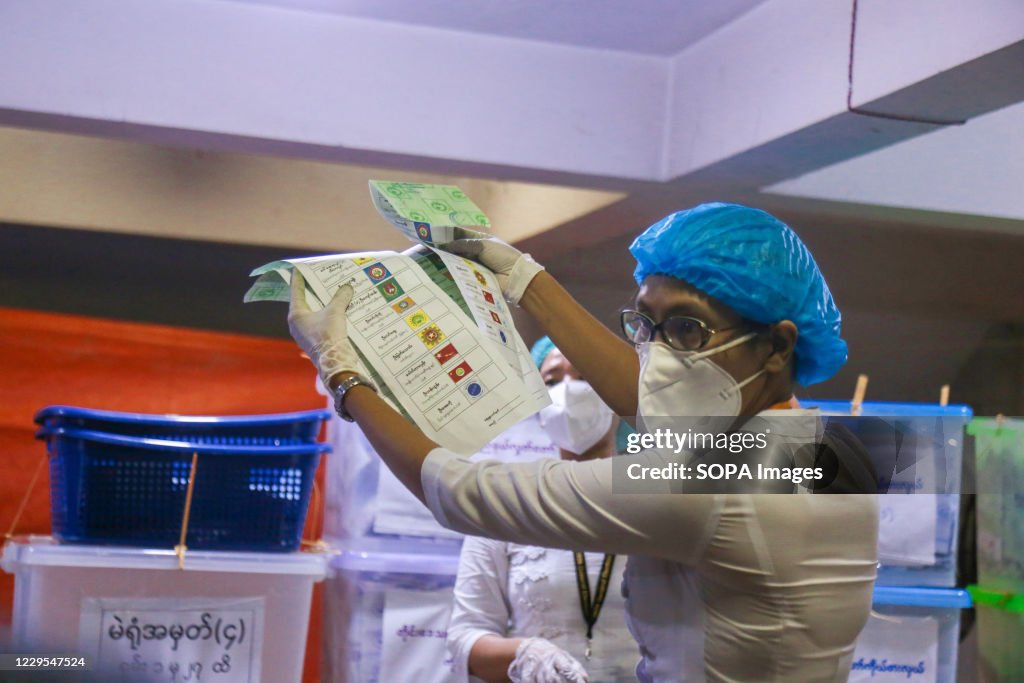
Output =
[{"x1": 288, "y1": 270, "x2": 359, "y2": 386}]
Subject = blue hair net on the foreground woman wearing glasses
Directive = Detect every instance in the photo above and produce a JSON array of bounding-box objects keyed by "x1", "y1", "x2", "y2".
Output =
[{"x1": 630, "y1": 203, "x2": 847, "y2": 386}]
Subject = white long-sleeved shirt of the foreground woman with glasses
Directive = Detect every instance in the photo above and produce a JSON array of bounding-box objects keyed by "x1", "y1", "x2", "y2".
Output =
[{"x1": 421, "y1": 411, "x2": 878, "y2": 683}]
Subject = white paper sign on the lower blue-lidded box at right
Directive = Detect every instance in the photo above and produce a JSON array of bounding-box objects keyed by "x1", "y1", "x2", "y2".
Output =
[{"x1": 849, "y1": 613, "x2": 939, "y2": 683}]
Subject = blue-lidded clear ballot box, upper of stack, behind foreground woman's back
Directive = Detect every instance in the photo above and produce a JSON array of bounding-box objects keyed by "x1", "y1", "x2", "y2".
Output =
[{"x1": 802, "y1": 400, "x2": 971, "y2": 587}]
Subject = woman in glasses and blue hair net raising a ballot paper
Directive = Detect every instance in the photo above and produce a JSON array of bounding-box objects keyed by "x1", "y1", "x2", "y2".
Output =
[{"x1": 289, "y1": 203, "x2": 879, "y2": 683}]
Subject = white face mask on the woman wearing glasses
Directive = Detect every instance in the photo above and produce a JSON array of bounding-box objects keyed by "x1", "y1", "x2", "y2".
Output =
[{"x1": 637, "y1": 332, "x2": 765, "y2": 418}]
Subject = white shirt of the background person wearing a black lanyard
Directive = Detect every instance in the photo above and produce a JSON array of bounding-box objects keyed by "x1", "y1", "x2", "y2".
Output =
[{"x1": 449, "y1": 537, "x2": 640, "y2": 683}]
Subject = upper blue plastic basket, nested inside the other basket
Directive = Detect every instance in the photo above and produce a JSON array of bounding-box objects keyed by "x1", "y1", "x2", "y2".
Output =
[{"x1": 35, "y1": 405, "x2": 331, "y2": 445}]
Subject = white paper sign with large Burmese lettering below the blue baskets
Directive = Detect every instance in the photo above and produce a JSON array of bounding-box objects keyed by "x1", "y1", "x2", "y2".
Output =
[{"x1": 79, "y1": 598, "x2": 264, "y2": 683}]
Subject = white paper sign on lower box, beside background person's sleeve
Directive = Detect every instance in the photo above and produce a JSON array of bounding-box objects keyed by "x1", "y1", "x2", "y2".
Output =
[{"x1": 380, "y1": 589, "x2": 457, "y2": 683}]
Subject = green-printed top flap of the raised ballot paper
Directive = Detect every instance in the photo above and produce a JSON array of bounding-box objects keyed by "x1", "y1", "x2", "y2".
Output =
[{"x1": 370, "y1": 180, "x2": 490, "y2": 245}]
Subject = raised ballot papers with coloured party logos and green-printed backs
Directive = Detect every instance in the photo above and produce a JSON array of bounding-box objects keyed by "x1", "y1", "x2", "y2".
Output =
[{"x1": 245, "y1": 181, "x2": 549, "y2": 455}]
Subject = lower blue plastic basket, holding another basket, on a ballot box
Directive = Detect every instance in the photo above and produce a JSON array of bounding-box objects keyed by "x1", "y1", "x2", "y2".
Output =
[{"x1": 40, "y1": 427, "x2": 330, "y2": 552}]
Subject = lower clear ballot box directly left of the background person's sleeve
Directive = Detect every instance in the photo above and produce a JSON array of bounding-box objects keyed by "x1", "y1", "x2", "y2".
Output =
[{"x1": 322, "y1": 551, "x2": 459, "y2": 683}]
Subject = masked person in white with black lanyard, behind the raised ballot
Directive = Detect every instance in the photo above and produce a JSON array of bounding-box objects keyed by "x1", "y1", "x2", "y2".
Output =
[{"x1": 449, "y1": 337, "x2": 637, "y2": 683}]
